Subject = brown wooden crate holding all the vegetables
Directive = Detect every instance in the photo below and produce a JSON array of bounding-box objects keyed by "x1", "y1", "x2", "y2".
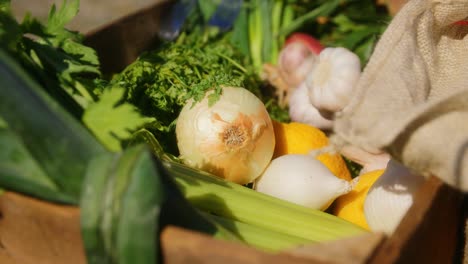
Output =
[{"x1": 0, "y1": 1, "x2": 468, "y2": 264}]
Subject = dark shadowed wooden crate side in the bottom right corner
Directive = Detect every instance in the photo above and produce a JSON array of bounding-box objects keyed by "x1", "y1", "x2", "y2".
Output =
[{"x1": 369, "y1": 177, "x2": 462, "y2": 264}]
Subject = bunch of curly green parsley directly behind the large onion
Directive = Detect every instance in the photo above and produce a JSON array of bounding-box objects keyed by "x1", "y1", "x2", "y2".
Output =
[{"x1": 106, "y1": 28, "x2": 262, "y2": 154}]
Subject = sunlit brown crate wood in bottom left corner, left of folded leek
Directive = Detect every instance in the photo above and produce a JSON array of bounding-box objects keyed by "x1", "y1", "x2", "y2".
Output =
[{"x1": 0, "y1": 192, "x2": 86, "y2": 264}]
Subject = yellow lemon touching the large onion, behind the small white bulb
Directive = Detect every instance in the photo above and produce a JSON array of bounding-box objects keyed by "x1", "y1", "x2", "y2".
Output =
[{"x1": 273, "y1": 121, "x2": 351, "y2": 181}]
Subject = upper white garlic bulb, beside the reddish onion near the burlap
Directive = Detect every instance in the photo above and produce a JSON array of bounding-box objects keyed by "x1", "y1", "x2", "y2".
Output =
[{"x1": 306, "y1": 47, "x2": 361, "y2": 113}]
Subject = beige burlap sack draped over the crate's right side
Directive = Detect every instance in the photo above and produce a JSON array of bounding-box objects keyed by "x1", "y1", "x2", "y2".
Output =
[{"x1": 332, "y1": 0, "x2": 468, "y2": 191}]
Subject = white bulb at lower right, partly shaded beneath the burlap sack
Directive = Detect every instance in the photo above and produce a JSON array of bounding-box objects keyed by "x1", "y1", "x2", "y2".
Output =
[{"x1": 364, "y1": 159, "x2": 424, "y2": 235}]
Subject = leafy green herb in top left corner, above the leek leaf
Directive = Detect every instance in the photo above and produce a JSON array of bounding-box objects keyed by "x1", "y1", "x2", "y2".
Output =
[{"x1": 0, "y1": 0, "x2": 101, "y2": 117}]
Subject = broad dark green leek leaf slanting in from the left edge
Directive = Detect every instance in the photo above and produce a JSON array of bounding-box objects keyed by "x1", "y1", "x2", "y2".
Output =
[{"x1": 0, "y1": 50, "x2": 104, "y2": 204}]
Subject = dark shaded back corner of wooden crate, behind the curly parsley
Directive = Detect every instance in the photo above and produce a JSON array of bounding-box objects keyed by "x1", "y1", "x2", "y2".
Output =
[{"x1": 84, "y1": 0, "x2": 171, "y2": 73}]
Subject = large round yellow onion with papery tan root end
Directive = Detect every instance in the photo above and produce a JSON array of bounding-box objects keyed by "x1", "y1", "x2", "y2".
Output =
[{"x1": 176, "y1": 87, "x2": 275, "y2": 184}]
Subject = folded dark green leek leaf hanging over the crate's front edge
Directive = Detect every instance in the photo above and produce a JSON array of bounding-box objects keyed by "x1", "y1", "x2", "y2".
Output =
[{"x1": 80, "y1": 144, "x2": 238, "y2": 264}]
